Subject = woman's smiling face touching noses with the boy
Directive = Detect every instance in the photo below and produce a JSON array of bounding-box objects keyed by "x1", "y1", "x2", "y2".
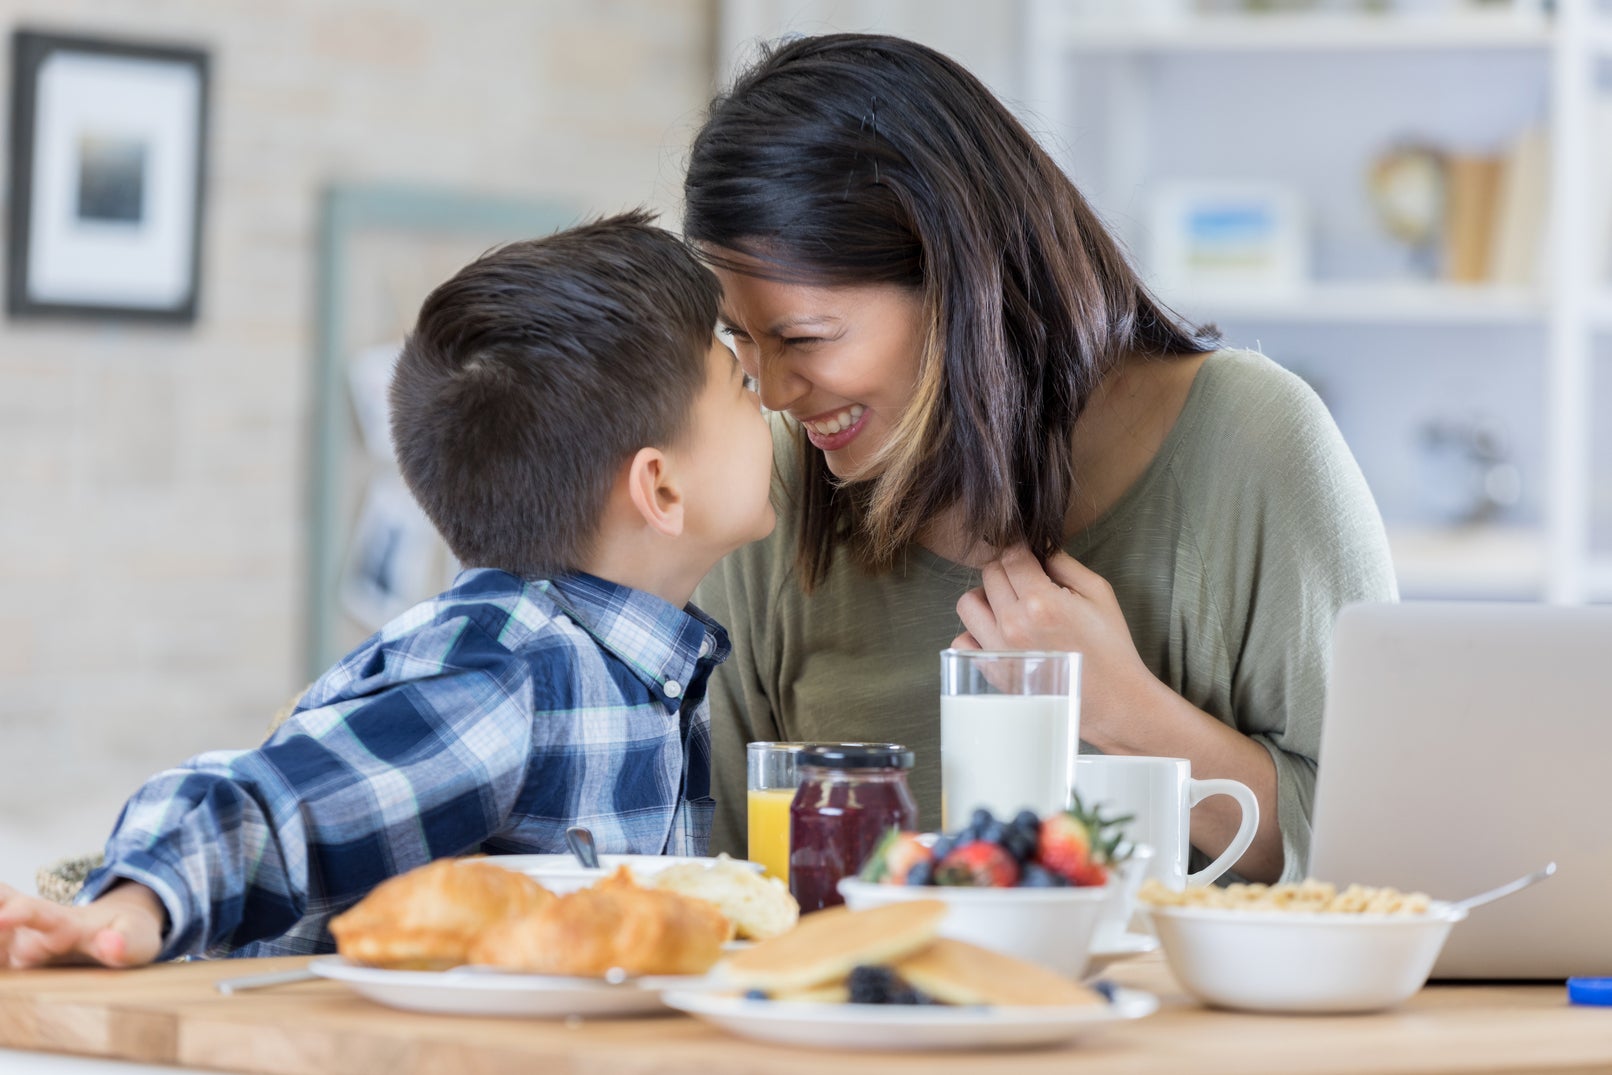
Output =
[{"x1": 716, "y1": 253, "x2": 925, "y2": 479}]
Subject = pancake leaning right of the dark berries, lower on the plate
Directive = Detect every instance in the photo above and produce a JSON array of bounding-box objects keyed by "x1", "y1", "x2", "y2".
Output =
[{"x1": 891, "y1": 936, "x2": 1103, "y2": 1007}]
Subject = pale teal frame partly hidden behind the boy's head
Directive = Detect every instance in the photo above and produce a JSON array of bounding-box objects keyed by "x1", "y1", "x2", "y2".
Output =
[{"x1": 303, "y1": 184, "x2": 582, "y2": 680}]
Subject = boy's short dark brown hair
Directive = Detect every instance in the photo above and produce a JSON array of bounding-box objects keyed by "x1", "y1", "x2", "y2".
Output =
[{"x1": 392, "y1": 210, "x2": 721, "y2": 577}]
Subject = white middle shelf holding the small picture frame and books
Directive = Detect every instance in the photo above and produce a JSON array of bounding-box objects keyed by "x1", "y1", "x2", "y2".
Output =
[{"x1": 1161, "y1": 284, "x2": 1547, "y2": 326}]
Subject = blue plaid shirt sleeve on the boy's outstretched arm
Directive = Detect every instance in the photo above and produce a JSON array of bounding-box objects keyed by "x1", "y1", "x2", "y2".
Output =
[{"x1": 81, "y1": 624, "x2": 532, "y2": 959}]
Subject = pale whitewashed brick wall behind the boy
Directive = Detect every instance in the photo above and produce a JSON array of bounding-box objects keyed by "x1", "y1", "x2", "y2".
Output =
[{"x1": 0, "y1": 0, "x2": 714, "y2": 883}]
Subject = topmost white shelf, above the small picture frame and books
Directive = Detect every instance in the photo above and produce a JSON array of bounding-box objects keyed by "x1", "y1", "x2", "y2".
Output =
[{"x1": 1064, "y1": 11, "x2": 1552, "y2": 53}]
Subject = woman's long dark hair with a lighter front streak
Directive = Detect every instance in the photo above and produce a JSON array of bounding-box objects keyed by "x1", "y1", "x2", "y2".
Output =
[{"x1": 683, "y1": 34, "x2": 1215, "y2": 590}]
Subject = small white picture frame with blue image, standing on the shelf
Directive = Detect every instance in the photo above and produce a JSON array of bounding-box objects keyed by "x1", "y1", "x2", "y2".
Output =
[{"x1": 1149, "y1": 182, "x2": 1309, "y2": 297}]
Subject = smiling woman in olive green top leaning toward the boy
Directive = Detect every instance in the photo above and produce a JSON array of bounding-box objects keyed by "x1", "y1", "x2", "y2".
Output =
[{"x1": 683, "y1": 34, "x2": 1394, "y2": 880}]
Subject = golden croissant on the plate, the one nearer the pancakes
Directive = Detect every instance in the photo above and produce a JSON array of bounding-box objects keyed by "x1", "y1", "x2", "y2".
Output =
[{"x1": 469, "y1": 867, "x2": 733, "y2": 977}]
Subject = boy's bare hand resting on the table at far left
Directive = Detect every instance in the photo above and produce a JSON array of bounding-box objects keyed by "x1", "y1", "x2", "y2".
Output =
[{"x1": 0, "y1": 882, "x2": 168, "y2": 967}]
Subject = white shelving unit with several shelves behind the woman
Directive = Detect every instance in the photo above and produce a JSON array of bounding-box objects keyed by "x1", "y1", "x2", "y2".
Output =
[{"x1": 1022, "y1": 0, "x2": 1612, "y2": 603}]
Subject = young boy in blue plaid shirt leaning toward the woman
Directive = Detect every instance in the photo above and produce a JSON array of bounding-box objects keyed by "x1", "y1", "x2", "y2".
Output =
[{"x1": 0, "y1": 213, "x2": 774, "y2": 967}]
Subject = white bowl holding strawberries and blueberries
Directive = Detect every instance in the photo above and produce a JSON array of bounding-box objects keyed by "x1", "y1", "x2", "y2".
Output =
[{"x1": 840, "y1": 877, "x2": 1116, "y2": 978}]
